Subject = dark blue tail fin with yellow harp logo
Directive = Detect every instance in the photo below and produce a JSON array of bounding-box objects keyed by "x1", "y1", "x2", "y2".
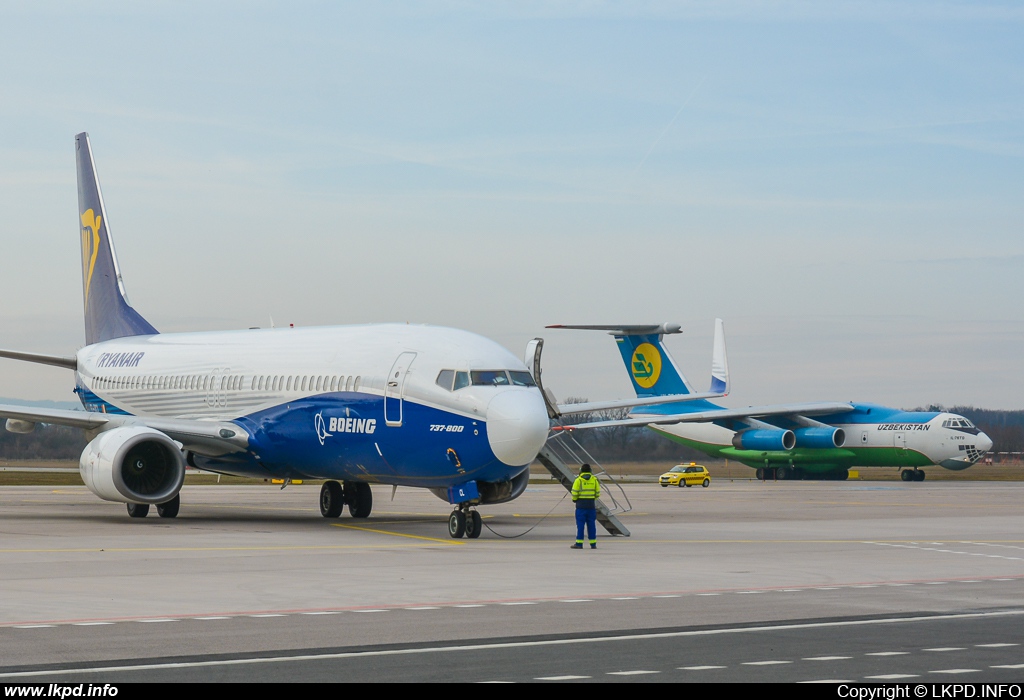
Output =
[{"x1": 75, "y1": 132, "x2": 158, "y2": 345}]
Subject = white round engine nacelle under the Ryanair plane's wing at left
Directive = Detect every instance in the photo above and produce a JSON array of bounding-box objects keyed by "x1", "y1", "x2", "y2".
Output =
[{"x1": 78, "y1": 426, "x2": 185, "y2": 504}]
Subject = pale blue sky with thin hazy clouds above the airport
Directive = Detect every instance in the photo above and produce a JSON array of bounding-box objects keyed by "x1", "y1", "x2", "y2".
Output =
[{"x1": 0, "y1": 1, "x2": 1024, "y2": 408}]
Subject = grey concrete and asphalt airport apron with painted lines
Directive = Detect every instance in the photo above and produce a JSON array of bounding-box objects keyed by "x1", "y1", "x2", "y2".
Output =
[{"x1": 0, "y1": 481, "x2": 1024, "y2": 683}]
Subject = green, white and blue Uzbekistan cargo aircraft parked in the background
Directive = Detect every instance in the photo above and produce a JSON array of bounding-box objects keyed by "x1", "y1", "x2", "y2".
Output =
[{"x1": 548, "y1": 319, "x2": 992, "y2": 481}]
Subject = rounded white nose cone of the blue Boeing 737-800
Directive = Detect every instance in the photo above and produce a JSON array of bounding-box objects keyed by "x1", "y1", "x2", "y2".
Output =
[{"x1": 487, "y1": 389, "x2": 548, "y2": 467}]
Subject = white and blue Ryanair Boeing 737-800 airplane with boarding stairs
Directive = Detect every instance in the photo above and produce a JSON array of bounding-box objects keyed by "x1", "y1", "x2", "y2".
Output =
[{"x1": 0, "y1": 133, "x2": 569, "y2": 537}]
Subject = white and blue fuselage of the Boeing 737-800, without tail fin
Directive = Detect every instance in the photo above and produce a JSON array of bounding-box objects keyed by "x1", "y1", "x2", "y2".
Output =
[{"x1": 76, "y1": 324, "x2": 548, "y2": 497}]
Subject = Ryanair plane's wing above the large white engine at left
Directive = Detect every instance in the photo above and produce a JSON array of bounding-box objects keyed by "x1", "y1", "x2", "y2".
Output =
[{"x1": 0, "y1": 404, "x2": 249, "y2": 456}]
